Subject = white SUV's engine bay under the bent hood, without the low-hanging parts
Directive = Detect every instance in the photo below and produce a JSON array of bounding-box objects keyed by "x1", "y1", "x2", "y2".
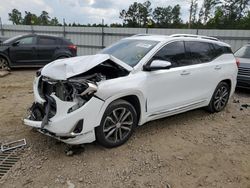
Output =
[{"x1": 38, "y1": 60, "x2": 129, "y2": 102}]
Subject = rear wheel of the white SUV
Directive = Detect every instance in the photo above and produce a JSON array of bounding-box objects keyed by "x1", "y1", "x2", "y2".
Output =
[{"x1": 207, "y1": 82, "x2": 230, "y2": 113}]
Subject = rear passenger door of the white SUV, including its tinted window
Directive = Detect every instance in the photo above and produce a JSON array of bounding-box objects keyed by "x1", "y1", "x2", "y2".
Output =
[{"x1": 185, "y1": 41, "x2": 220, "y2": 102}]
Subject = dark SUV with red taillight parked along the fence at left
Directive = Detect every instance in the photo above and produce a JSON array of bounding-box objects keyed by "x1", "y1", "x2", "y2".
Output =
[{"x1": 0, "y1": 34, "x2": 77, "y2": 69}]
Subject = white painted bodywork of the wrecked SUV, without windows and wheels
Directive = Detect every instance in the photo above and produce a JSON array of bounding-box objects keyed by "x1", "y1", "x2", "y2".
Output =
[{"x1": 24, "y1": 36, "x2": 237, "y2": 144}]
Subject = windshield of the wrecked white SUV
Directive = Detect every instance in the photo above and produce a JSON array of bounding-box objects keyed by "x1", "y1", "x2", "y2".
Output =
[{"x1": 100, "y1": 39, "x2": 158, "y2": 67}]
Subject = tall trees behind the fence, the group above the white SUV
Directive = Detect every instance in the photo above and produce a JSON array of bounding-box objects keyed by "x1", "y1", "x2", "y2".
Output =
[{"x1": 120, "y1": 0, "x2": 250, "y2": 29}]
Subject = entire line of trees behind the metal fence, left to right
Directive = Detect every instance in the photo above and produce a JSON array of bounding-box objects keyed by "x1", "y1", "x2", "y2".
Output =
[{"x1": 9, "y1": 0, "x2": 250, "y2": 29}]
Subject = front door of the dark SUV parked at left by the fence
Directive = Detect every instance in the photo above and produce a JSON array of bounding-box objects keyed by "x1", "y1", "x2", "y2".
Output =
[{"x1": 9, "y1": 36, "x2": 37, "y2": 66}]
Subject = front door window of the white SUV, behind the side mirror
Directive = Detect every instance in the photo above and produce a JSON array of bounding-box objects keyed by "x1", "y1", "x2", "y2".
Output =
[{"x1": 153, "y1": 41, "x2": 187, "y2": 67}]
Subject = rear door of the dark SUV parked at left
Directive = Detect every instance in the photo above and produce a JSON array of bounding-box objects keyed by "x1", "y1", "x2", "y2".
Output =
[{"x1": 37, "y1": 36, "x2": 59, "y2": 64}]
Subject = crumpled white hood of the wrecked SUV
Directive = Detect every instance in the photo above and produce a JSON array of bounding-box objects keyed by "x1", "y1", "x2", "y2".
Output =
[{"x1": 41, "y1": 54, "x2": 133, "y2": 80}]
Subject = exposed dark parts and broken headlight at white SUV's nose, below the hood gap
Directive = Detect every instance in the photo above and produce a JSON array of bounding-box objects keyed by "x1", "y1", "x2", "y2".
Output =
[{"x1": 29, "y1": 76, "x2": 97, "y2": 126}]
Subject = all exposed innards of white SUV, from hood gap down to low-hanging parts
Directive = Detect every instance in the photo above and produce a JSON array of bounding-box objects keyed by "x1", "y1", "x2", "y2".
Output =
[{"x1": 30, "y1": 60, "x2": 129, "y2": 124}]
